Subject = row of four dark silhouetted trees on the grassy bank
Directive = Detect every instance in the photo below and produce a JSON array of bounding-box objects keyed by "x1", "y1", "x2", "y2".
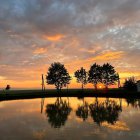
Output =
[{"x1": 46, "y1": 62, "x2": 119, "y2": 91}]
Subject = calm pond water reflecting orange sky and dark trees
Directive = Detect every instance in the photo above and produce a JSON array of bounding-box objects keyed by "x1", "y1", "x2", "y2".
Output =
[{"x1": 0, "y1": 98, "x2": 140, "y2": 140}]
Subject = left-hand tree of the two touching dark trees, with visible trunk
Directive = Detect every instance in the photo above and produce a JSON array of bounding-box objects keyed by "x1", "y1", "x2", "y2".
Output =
[{"x1": 88, "y1": 63, "x2": 101, "y2": 90}]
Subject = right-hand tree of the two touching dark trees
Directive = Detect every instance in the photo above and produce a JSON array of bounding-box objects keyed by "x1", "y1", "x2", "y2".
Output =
[{"x1": 101, "y1": 63, "x2": 119, "y2": 88}]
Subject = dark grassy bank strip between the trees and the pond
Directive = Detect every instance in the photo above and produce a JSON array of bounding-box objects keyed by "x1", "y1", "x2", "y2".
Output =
[{"x1": 0, "y1": 89, "x2": 140, "y2": 101}]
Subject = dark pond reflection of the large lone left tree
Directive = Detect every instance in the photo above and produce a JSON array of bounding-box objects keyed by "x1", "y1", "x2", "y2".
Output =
[{"x1": 46, "y1": 98, "x2": 72, "y2": 128}]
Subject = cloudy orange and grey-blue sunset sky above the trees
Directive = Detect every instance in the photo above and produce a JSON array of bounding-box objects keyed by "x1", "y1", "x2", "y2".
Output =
[{"x1": 0, "y1": 0, "x2": 140, "y2": 88}]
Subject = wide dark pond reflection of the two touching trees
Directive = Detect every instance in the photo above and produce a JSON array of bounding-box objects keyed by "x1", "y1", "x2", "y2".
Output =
[{"x1": 89, "y1": 98, "x2": 122, "y2": 125}]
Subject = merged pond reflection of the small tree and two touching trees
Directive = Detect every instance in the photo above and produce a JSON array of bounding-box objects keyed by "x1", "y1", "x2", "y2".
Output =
[{"x1": 76, "y1": 98, "x2": 122, "y2": 125}]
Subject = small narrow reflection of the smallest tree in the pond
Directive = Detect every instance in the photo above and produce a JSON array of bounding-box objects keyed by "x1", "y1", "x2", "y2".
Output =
[{"x1": 76, "y1": 98, "x2": 89, "y2": 121}]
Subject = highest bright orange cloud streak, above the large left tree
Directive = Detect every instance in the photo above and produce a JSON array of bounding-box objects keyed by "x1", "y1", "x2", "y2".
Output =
[{"x1": 43, "y1": 34, "x2": 64, "y2": 41}]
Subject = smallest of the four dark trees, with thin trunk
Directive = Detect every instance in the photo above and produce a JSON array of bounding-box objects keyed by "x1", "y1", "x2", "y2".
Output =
[{"x1": 74, "y1": 67, "x2": 88, "y2": 90}]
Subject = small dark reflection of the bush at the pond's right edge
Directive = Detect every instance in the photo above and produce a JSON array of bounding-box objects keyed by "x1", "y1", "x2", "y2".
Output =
[{"x1": 126, "y1": 98, "x2": 140, "y2": 109}]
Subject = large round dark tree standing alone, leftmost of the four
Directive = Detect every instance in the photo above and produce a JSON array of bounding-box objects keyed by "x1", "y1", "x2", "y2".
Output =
[{"x1": 46, "y1": 62, "x2": 71, "y2": 91}]
